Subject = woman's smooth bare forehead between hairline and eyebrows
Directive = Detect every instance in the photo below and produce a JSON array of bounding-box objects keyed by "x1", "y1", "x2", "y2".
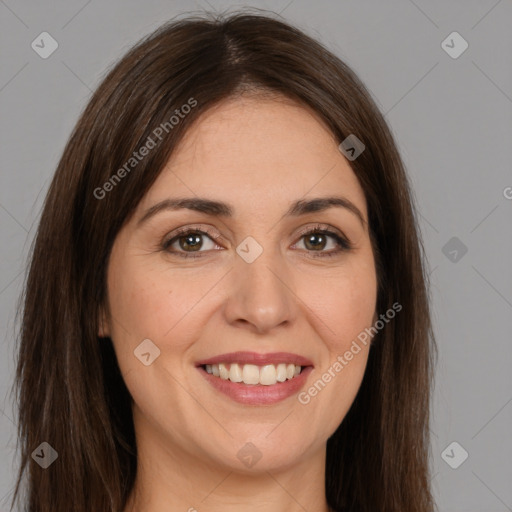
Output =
[{"x1": 141, "y1": 97, "x2": 366, "y2": 218}]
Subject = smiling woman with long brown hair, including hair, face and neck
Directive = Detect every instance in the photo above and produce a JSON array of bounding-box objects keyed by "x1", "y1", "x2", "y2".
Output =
[{"x1": 13, "y1": 13, "x2": 434, "y2": 512}]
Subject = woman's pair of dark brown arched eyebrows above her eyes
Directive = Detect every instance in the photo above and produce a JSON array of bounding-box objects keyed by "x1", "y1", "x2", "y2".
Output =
[{"x1": 137, "y1": 196, "x2": 367, "y2": 227}]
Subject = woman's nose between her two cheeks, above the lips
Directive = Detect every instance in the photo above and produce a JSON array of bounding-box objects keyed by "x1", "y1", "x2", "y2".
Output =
[{"x1": 224, "y1": 246, "x2": 297, "y2": 334}]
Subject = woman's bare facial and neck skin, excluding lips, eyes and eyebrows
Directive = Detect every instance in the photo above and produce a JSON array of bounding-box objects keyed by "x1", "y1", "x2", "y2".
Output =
[{"x1": 99, "y1": 96, "x2": 377, "y2": 512}]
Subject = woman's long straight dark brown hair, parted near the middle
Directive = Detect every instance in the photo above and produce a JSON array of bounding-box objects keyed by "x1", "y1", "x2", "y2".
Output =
[{"x1": 13, "y1": 12, "x2": 435, "y2": 512}]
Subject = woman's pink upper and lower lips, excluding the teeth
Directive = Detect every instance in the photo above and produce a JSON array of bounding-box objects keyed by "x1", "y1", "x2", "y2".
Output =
[{"x1": 196, "y1": 352, "x2": 313, "y2": 405}]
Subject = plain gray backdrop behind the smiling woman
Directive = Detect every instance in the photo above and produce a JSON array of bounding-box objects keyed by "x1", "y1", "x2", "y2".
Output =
[{"x1": 0, "y1": 0, "x2": 512, "y2": 512}]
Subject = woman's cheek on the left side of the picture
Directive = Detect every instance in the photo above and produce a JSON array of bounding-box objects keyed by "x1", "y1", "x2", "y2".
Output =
[{"x1": 108, "y1": 257, "x2": 215, "y2": 416}]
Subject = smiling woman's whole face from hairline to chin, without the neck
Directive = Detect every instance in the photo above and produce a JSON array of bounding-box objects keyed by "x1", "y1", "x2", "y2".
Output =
[{"x1": 99, "y1": 97, "x2": 377, "y2": 471}]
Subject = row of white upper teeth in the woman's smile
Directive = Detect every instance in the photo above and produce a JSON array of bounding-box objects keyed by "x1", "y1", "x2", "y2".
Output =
[{"x1": 205, "y1": 363, "x2": 302, "y2": 386}]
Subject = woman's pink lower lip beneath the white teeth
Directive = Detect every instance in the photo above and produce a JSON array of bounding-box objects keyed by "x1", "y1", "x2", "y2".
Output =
[{"x1": 197, "y1": 366, "x2": 313, "y2": 405}]
